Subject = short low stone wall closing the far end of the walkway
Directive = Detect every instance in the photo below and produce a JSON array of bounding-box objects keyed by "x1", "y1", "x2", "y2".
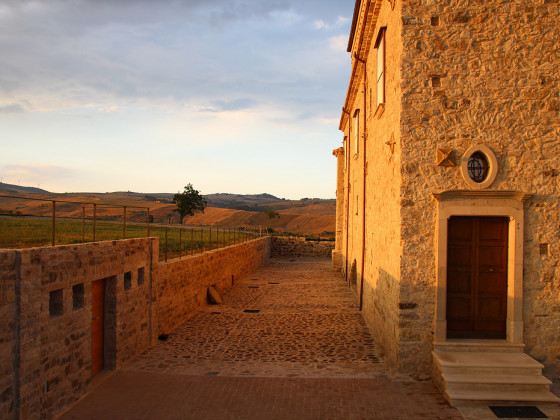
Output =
[{"x1": 270, "y1": 236, "x2": 335, "y2": 258}]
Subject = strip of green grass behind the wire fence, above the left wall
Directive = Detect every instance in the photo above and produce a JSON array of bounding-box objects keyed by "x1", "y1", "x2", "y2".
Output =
[{"x1": 0, "y1": 217, "x2": 258, "y2": 260}]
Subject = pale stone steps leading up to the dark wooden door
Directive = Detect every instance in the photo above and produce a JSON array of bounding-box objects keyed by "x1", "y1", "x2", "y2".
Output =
[{"x1": 433, "y1": 345, "x2": 560, "y2": 406}]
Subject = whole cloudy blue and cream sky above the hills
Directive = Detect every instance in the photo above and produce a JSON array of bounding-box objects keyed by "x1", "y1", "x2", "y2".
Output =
[{"x1": 0, "y1": 0, "x2": 354, "y2": 199}]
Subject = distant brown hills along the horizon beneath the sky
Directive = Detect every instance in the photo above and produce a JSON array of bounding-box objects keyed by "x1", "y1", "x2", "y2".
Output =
[{"x1": 0, "y1": 183, "x2": 336, "y2": 236}]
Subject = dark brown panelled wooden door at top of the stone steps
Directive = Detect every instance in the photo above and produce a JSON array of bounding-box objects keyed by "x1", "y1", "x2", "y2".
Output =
[{"x1": 447, "y1": 216, "x2": 508, "y2": 338}]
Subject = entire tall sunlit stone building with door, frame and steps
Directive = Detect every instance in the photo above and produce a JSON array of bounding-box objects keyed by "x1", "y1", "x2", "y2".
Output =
[{"x1": 333, "y1": 0, "x2": 560, "y2": 403}]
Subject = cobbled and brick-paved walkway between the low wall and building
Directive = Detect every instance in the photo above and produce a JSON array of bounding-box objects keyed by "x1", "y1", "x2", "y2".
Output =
[{"x1": 61, "y1": 260, "x2": 462, "y2": 420}]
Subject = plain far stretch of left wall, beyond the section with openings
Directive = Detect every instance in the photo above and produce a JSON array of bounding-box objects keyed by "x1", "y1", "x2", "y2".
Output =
[{"x1": 154, "y1": 238, "x2": 271, "y2": 334}]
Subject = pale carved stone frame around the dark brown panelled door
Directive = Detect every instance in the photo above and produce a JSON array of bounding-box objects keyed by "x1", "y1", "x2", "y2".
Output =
[{"x1": 433, "y1": 190, "x2": 531, "y2": 343}]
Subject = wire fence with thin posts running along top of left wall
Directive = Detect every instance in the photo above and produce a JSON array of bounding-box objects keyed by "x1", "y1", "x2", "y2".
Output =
[{"x1": 0, "y1": 194, "x2": 266, "y2": 261}]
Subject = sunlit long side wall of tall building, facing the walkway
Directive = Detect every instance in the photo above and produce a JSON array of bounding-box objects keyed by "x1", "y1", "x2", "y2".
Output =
[{"x1": 343, "y1": 1, "x2": 402, "y2": 374}]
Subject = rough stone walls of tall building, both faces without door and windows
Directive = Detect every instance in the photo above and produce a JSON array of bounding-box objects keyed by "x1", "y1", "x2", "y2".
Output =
[{"x1": 340, "y1": 0, "x2": 560, "y2": 378}]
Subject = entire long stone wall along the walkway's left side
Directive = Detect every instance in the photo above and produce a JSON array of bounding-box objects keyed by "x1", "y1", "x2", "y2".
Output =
[{"x1": 0, "y1": 238, "x2": 270, "y2": 419}]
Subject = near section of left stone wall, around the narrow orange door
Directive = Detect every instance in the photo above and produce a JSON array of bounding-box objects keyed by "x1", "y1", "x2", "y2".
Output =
[{"x1": 4, "y1": 239, "x2": 157, "y2": 419}]
